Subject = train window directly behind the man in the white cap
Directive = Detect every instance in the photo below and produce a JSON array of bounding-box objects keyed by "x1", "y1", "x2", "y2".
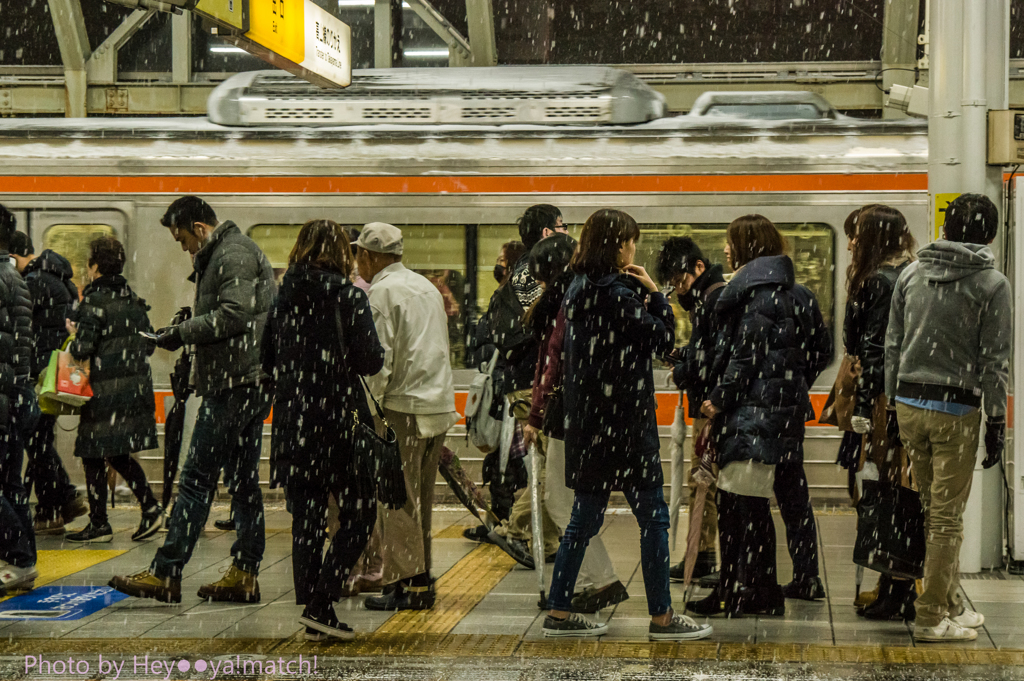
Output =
[{"x1": 249, "y1": 224, "x2": 466, "y2": 369}]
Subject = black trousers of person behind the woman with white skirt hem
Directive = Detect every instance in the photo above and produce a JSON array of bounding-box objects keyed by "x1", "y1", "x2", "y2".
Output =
[{"x1": 775, "y1": 462, "x2": 818, "y2": 581}]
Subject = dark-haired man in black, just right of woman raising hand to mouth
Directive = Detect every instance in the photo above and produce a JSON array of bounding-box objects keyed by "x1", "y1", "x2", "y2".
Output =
[{"x1": 656, "y1": 237, "x2": 725, "y2": 582}]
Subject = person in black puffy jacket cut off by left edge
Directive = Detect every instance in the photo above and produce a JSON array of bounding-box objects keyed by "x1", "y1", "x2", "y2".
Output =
[{"x1": 0, "y1": 206, "x2": 39, "y2": 595}]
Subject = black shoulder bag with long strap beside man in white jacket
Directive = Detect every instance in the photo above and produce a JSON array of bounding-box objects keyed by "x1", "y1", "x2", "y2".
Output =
[{"x1": 335, "y1": 308, "x2": 409, "y2": 509}]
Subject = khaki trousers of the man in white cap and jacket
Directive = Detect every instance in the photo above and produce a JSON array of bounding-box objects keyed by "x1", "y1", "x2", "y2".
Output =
[{"x1": 377, "y1": 409, "x2": 444, "y2": 584}]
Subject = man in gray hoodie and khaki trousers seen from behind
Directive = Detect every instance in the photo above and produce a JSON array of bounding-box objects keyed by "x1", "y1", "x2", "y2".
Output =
[{"x1": 886, "y1": 194, "x2": 1013, "y2": 641}]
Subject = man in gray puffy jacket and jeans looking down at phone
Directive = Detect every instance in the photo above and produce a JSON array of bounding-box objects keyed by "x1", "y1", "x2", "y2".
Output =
[{"x1": 111, "y1": 197, "x2": 275, "y2": 603}]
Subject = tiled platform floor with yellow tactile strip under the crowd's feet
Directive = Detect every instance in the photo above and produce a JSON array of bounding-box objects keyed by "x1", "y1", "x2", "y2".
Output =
[{"x1": 0, "y1": 505, "x2": 1024, "y2": 665}]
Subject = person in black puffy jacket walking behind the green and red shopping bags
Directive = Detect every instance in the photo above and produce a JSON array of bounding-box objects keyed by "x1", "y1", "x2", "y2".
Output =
[{"x1": 10, "y1": 231, "x2": 89, "y2": 535}]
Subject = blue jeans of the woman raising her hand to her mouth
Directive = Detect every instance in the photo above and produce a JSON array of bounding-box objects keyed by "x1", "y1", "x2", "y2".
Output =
[{"x1": 548, "y1": 487, "x2": 672, "y2": 618}]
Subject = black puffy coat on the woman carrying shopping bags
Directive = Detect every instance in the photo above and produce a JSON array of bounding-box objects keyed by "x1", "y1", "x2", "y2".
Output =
[{"x1": 68, "y1": 274, "x2": 157, "y2": 459}]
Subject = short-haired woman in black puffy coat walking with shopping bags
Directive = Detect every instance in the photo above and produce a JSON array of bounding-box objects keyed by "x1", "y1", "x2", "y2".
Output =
[{"x1": 65, "y1": 237, "x2": 164, "y2": 543}]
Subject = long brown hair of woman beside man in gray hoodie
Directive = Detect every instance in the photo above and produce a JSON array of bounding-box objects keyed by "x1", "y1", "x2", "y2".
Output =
[{"x1": 846, "y1": 204, "x2": 916, "y2": 295}]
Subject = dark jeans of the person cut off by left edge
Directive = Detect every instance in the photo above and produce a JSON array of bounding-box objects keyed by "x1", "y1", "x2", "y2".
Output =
[{"x1": 0, "y1": 386, "x2": 39, "y2": 567}]
